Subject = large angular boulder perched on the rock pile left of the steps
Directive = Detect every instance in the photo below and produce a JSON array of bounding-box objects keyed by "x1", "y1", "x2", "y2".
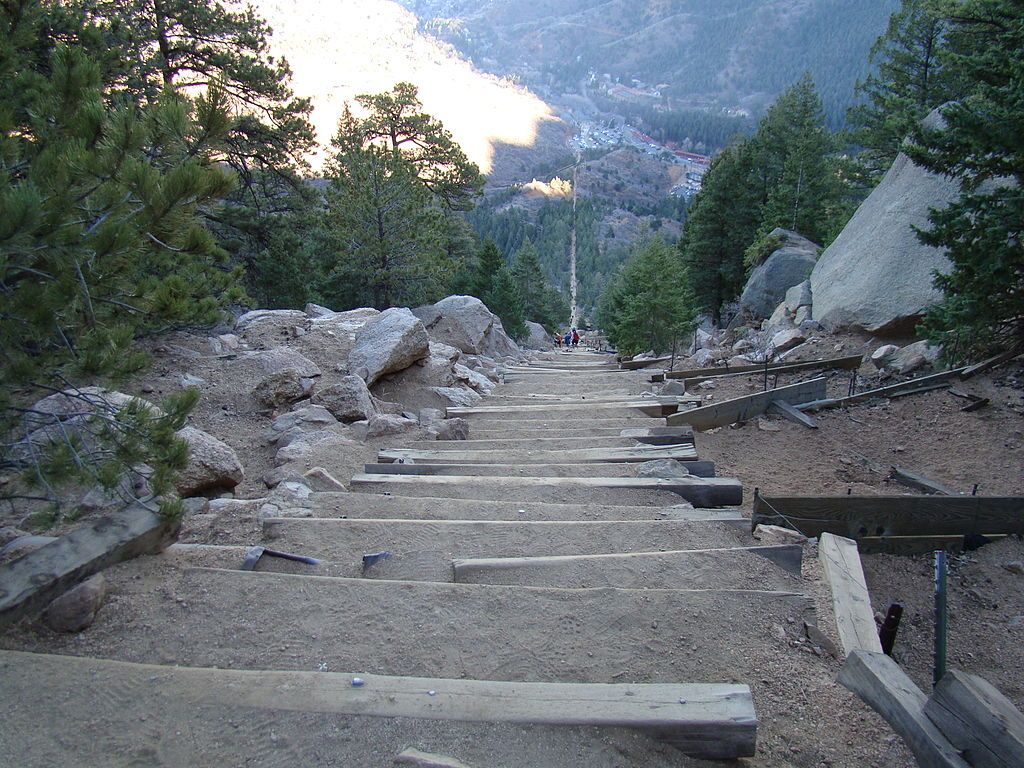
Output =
[{"x1": 348, "y1": 308, "x2": 430, "y2": 386}]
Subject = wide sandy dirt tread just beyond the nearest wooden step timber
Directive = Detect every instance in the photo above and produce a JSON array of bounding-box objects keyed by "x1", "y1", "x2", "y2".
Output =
[{"x1": 0, "y1": 558, "x2": 811, "y2": 683}]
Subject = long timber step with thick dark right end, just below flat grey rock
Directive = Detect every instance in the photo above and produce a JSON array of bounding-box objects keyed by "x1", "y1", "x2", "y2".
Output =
[{"x1": 351, "y1": 474, "x2": 743, "y2": 507}]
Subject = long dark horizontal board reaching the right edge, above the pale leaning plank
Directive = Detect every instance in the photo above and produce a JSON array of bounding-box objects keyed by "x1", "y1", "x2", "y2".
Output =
[{"x1": 751, "y1": 496, "x2": 1024, "y2": 539}]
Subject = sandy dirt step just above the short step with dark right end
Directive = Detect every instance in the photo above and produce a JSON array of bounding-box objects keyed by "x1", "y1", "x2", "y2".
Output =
[{"x1": 261, "y1": 518, "x2": 760, "y2": 589}]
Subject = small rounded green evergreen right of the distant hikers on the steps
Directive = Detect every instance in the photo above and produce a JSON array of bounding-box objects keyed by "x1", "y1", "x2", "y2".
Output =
[{"x1": 598, "y1": 239, "x2": 696, "y2": 354}]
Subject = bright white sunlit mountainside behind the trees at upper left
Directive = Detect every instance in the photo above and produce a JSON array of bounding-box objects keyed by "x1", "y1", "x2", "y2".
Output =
[{"x1": 254, "y1": 0, "x2": 568, "y2": 182}]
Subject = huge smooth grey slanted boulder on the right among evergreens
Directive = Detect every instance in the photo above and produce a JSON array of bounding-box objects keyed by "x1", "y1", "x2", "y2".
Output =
[{"x1": 811, "y1": 112, "x2": 961, "y2": 334}]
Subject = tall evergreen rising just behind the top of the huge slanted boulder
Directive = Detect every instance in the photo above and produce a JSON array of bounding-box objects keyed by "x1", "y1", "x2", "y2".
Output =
[{"x1": 849, "y1": 0, "x2": 958, "y2": 179}]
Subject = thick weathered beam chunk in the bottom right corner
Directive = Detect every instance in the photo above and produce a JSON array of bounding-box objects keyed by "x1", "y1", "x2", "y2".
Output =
[{"x1": 925, "y1": 670, "x2": 1024, "y2": 768}]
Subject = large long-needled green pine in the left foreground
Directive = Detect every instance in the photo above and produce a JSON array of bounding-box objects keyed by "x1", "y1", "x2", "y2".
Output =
[{"x1": 0, "y1": 2, "x2": 240, "y2": 512}]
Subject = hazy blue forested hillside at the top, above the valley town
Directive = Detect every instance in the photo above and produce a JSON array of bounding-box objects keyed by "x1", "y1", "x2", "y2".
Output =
[{"x1": 403, "y1": 0, "x2": 899, "y2": 122}]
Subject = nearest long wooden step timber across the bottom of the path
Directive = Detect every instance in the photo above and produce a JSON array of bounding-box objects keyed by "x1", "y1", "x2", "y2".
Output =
[{"x1": 0, "y1": 651, "x2": 757, "y2": 760}]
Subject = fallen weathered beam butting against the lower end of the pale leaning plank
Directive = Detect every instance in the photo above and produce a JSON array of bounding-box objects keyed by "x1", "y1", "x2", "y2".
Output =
[{"x1": 839, "y1": 650, "x2": 969, "y2": 768}]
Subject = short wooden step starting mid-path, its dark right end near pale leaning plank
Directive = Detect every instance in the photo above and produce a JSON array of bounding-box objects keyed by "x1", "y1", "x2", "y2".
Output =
[{"x1": 453, "y1": 545, "x2": 803, "y2": 590}]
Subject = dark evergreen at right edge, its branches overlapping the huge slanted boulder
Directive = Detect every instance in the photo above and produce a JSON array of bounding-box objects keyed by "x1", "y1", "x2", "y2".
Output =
[{"x1": 907, "y1": 0, "x2": 1024, "y2": 354}]
